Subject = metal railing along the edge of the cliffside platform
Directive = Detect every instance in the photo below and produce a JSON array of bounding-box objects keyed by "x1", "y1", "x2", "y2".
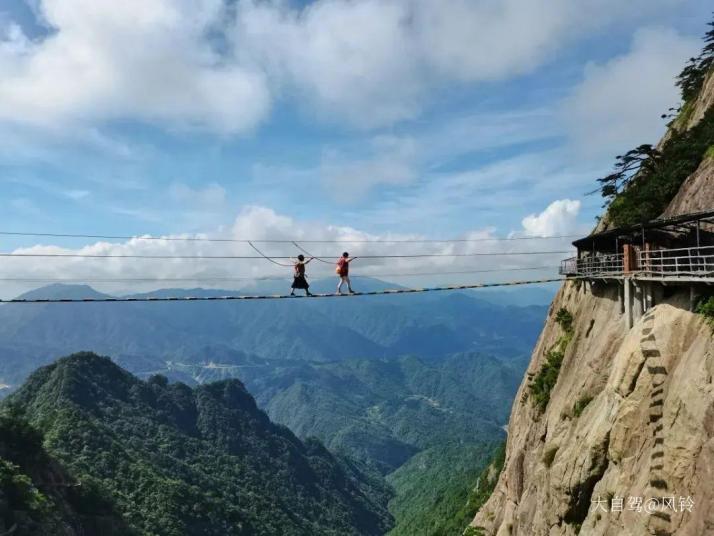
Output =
[{"x1": 559, "y1": 246, "x2": 714, "y2": 279}]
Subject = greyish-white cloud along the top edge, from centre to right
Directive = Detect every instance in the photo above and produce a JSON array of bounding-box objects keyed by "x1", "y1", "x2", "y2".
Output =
[{"x1": 233, "y1": 0, "x2": 681, "y2": 127}]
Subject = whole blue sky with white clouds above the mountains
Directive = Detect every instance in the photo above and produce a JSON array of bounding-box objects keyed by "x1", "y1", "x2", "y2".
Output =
[{"x1": 0, "y1": 0, "x2": 711, "y2": 297}]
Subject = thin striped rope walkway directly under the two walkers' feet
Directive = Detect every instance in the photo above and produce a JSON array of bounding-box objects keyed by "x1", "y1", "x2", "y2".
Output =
[{"x1": 0, "y1": 278, "x2": 565, "y2": 303}]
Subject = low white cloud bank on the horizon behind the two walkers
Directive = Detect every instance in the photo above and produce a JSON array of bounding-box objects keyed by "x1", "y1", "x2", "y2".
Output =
[{"x1": 0, "y1": 201, "x2": 577, "y2": 297}]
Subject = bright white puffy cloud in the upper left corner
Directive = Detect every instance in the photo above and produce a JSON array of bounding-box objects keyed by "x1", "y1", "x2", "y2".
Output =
[{"x1": 0, "y1": 0, "x2": 270, "y2": 133}]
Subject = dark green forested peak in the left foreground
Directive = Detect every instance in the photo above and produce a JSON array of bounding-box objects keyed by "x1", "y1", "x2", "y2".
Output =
[{"x1": 6, "y1": 353, "x2": 391, "y2": 536}]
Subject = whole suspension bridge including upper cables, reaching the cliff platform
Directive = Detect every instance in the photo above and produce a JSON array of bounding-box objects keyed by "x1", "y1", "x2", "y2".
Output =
[{"x1": 0, "y1": 227, "x2": 572, "y2": 304}]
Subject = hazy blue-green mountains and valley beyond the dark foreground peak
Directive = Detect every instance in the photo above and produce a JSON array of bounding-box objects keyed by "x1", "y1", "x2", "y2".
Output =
[{"x1": 0, "y1": 282, "x2": 545, "y2": 534}]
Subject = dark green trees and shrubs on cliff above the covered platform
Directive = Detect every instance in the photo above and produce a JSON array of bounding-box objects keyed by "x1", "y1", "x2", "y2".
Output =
[{"x1": 598, "y1": 16, "x2": 714, "y2": 226}]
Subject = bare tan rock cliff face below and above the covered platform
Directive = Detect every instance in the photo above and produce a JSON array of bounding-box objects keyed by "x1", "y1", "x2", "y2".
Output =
[{"x1": 470, "y1": 60, "x2": 714, "y2": 536}]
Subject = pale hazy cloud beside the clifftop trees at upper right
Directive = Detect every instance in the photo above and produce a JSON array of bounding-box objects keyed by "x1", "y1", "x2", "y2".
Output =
[{"x1": 562, "y1": 28, "x2": 700, "y2": 157}]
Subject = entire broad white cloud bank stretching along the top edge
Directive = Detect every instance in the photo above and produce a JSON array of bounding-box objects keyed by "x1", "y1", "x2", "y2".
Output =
[{"x1": 0, "y1": 0, "x2": 679, "y2": 134}]
